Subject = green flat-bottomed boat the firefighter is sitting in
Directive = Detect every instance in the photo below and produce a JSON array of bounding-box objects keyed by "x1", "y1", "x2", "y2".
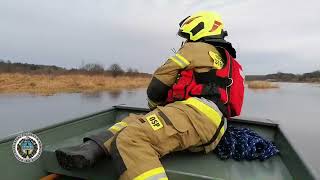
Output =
[{"x1": 0, "y1": 105, "x2": 316, "y2": 180}]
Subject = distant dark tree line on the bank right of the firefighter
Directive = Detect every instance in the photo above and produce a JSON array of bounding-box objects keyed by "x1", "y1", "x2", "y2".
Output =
[{"x1": 246, "y1": 70, "x2": 320, "y2": 82}]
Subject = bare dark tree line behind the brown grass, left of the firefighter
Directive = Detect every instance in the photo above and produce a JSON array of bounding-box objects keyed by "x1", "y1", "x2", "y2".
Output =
[{"x1": 0, "y1": 60, "x2": 150, "y2": 77}]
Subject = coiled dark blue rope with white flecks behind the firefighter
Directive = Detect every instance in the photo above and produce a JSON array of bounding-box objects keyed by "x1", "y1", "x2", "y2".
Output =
[{"x1": 215, "y1": 126, "x2": 279, "y2": 161}]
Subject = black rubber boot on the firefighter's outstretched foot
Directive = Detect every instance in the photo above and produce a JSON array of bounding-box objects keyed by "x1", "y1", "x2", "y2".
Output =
[{"x1": 55, "y1": 140, "x2": 106, "y2": 170}]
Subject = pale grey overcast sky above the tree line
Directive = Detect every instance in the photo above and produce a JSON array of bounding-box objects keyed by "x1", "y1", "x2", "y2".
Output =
[{"x1": 0, "y1": 0, "x2": 320, "y2": 74}]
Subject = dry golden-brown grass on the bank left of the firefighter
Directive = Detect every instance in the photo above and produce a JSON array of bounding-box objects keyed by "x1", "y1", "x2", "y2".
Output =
[{"x1": 0, "y1": 73, "x2": 151, "y2": 95}]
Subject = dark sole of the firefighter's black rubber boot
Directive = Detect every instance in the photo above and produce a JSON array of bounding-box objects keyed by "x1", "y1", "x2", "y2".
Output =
[{"x1": 55, "y1": 150, "x2": 91, "y2": 170}]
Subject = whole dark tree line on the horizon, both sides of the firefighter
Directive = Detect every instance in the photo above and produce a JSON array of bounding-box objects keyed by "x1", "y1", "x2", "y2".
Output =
[{"x1": 0, "y1": 59, "x2": 320, "y2": 82}]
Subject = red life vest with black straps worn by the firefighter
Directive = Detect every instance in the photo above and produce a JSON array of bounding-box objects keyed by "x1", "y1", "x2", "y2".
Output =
[{"x1": 166, "y1": 50, "x2": 244, "y2": 117}]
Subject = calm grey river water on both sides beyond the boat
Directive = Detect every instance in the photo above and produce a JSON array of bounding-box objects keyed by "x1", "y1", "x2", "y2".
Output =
[{"x1": 0, "y1": 83, "x2": 320, "y2": 175}]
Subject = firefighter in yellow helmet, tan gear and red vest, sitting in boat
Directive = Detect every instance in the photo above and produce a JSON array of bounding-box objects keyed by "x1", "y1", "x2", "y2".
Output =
[{"x1": 56, "y1": 11, "x2": 242, "y2": 180}]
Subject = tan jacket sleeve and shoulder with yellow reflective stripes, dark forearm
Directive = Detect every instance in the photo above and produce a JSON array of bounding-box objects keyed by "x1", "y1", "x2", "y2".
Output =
[{"x1": 147, "y1": 42, "x2": 221, "y2": 109}]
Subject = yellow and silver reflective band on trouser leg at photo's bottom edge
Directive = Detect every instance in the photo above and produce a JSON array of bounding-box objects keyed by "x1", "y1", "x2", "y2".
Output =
[{"x1": 133, "y1": 167, "x2": 168, "y2": 180}]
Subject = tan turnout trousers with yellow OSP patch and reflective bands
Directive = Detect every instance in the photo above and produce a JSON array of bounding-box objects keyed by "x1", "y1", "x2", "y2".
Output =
[{"x1": 88, "y1": 98, "x2": 226, "y2": 180}]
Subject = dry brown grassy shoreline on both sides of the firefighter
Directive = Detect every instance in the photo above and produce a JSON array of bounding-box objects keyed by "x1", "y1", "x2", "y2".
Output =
[{"x1": 0, "y1": 73, "x2": 320, "y2": 96}]
